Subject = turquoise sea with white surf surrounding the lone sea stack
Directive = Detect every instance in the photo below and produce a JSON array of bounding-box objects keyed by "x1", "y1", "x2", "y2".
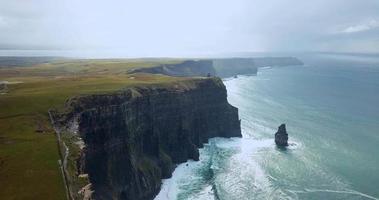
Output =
[{"x1": 156, "y1": 55, "x2": 379, "y2": 200}]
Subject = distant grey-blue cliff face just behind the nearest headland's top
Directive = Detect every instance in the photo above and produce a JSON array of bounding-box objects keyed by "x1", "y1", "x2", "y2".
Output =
[{"x1": 131, "y1": 60, "x2": 216, "y2": 77}]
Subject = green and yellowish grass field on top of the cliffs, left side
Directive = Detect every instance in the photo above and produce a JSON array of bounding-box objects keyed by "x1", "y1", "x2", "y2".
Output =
[{"x1": 0, "y1": 59, "x2": 187, "y2": 200}]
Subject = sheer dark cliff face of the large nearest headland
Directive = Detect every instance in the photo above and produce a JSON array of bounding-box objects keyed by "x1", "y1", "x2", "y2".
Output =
[{"x1": 59, "y1": 78, "x2": 241, "y2": 200}]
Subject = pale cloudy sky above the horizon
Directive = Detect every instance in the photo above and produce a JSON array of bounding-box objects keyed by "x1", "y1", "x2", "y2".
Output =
[{"x1": 0, "y1": 0, "x2": 379, "y2": 57}]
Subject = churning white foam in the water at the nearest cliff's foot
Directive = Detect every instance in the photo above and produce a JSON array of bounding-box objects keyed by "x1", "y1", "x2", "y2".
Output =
[{"x1": 155, "y1": 138, "x2": 280, "y2": 200}]
